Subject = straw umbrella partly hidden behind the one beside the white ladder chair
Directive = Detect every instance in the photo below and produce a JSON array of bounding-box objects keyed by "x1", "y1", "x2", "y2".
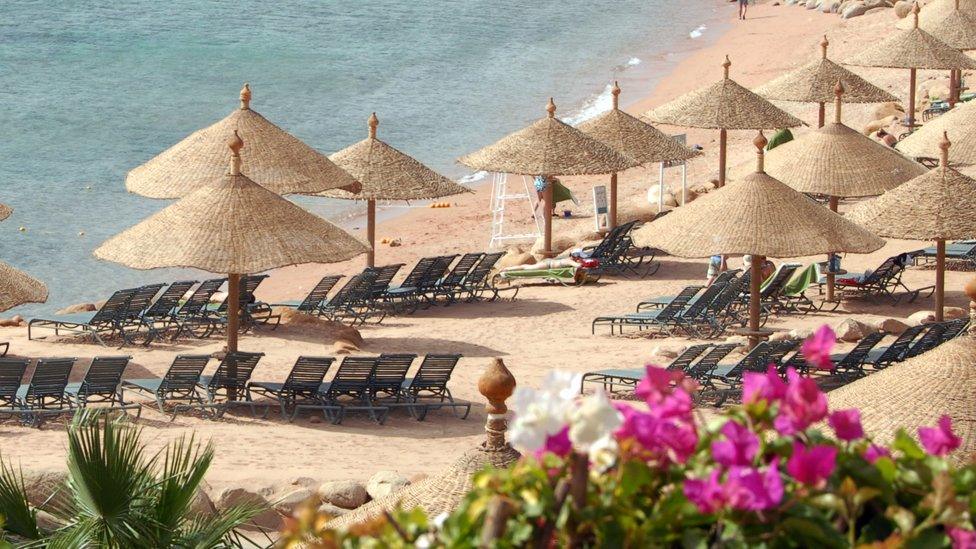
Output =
[{"x1": 578, "y1": 82, "x2": 700, "y2": 229}]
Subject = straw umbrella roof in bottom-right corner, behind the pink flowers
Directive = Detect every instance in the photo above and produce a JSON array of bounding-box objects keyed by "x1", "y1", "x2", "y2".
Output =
[{"x1": 827, "y1": 328, "x2": 976, "y2": 464}]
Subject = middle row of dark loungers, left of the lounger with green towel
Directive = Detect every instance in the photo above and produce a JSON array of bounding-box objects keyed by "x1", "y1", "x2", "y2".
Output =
[{"x1": 274, "y1": 252, "x2": 518, "y2": 325}]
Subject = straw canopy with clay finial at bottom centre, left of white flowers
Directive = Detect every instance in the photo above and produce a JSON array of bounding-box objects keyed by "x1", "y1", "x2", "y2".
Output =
[{"x1": 329, "y1": 358, "x2": 521, "y2": 529}]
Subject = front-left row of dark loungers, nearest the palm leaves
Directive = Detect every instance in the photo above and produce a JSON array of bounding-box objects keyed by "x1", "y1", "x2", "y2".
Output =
[{"x1": 0, "y1": 352, "x2": 471, "y2": 426}]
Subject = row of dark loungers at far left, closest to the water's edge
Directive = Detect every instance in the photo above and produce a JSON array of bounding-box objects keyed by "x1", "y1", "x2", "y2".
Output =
[{"x1": 27, "y1": 275, "x2": 280, "y2": 345}]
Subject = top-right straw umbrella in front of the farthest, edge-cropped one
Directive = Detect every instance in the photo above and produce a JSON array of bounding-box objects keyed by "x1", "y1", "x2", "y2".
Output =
[{"x1": 844, "y1": 4, "x2": 976, "y2": 128}]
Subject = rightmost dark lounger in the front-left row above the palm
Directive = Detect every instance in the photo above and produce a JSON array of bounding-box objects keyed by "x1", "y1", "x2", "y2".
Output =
[{"x1": 400, "y1": 355, "x2": 471, "y2": 421}]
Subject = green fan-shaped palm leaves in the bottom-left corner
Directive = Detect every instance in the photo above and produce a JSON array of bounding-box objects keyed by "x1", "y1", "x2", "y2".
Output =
[{"x1": 0, "y1": 413, "x2": 262, "y2": 549}]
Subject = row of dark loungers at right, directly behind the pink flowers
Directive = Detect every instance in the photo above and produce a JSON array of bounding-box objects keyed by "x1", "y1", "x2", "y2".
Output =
[{"x1": 581, "y1": 319, "x2": 969, "y2": 404}]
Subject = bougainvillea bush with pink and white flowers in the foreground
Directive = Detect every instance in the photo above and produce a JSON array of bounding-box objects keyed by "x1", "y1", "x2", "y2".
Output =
[{"x1": 292, "y1": 328, "x2": 976, "y2": 548}]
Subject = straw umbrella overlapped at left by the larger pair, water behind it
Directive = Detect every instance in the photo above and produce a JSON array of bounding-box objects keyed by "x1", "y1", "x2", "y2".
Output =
[{"x1": 322, "y1": 113, "x2": 470, "y2": 267}]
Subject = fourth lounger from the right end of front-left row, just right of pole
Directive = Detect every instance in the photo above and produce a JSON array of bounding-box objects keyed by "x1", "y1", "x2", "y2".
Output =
[{"x1": 248, "y1": 356, "x2": 340, "y2": 421}]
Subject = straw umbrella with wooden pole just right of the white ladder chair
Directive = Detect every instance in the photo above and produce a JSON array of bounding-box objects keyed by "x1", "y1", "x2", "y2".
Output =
[{"x1": 458, "y1": 97, "x2": 640, "y2": 257}]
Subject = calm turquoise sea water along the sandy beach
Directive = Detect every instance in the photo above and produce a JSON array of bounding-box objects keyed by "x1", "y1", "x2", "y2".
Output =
[{"x1": 0, "y1": 0, "x2": 725, "y2": 315}]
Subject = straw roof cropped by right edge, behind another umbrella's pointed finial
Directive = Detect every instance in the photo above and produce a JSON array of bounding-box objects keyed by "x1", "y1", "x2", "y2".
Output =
[{"x1": 896, "y1": 101, "x2": 976, "y2": 164}]
